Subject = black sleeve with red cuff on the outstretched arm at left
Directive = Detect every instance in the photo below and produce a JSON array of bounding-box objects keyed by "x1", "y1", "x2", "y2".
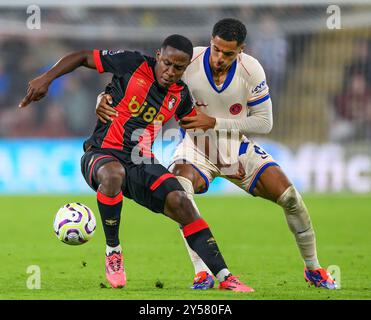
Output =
[{"x1": 93, "y1": 49, "x2": 144, "y2": 75}]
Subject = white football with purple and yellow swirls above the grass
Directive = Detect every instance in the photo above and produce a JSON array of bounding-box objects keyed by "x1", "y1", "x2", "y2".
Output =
[{"x1": 54, "y1": 202, "x2": 96, "y2": 245}]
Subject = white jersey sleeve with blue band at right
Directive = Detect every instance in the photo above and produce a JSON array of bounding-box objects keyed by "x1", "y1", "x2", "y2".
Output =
[{"x1": 247, "y1": 60, "x2": 270, "y2": 107}]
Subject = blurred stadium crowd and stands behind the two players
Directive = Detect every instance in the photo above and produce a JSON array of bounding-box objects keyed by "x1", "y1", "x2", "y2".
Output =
[{"x1": 0, "y1": 6, "x2": 371, "y2": 142}]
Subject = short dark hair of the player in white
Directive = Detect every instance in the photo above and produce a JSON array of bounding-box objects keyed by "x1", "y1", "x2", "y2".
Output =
[{"x1": 212, "y1": 18, "x2": 247, "y2": 45}]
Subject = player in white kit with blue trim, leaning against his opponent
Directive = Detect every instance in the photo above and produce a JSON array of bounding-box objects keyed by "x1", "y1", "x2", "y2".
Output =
[{"x1": 96, "y1": 19, "x2": 336, "y2": 289}]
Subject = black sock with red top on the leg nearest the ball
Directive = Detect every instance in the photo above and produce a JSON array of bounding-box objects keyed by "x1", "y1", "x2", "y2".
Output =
[{"x1": 97, "y1": 190, "x2": 123, "y2": 247}]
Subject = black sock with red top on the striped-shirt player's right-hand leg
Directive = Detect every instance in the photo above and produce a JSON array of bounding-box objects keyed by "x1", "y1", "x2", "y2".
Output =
[{"x1": 183, "y1": 218, "x2": 228, "y2": 276}]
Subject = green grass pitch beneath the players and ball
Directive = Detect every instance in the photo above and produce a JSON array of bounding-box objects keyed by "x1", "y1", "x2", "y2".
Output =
[{"x1": 0, "y1": 195, "x2": 371, "y2": 300}]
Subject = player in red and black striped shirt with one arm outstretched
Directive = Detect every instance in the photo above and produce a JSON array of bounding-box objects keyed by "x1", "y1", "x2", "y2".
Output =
[{"x1": 19, "y1": 35, "x2": 241, "y2": 287}]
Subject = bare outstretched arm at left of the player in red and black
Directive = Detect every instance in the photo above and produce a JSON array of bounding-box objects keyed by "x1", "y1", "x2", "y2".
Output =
[{"x1": 19, "y1": 50, "x2": 96, "y2": 108}]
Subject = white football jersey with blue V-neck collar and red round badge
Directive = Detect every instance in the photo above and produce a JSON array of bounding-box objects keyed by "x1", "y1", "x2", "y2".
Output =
[{"x1": 183, "y1": 47, "x2": 269, "y2": 163}]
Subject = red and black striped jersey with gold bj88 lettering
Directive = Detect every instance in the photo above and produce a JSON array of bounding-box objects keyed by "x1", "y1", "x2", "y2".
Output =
[{"x1": 84, "y1": 50, "x2": 196, "y2": 157}]
